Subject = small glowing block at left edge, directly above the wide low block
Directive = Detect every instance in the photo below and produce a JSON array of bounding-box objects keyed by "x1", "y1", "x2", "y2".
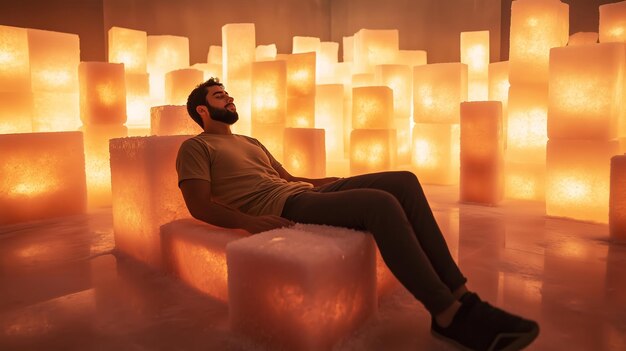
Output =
[{"x1": 0, "y1": 91, "x2": 33, "y2": 134}]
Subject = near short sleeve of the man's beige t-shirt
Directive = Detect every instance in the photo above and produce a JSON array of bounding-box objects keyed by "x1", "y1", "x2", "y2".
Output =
[{"x1": 176, "y1": 138, "x2": 211, "y2": 185}]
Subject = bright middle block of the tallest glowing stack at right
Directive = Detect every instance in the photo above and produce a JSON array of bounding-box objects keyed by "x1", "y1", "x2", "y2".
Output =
[{"x1": 506, "y1": 84, "x2": 548, "y2": 164}]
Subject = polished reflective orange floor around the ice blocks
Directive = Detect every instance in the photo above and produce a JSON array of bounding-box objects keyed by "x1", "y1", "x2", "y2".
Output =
[{"x1": 0, "y1": 187, "x2": 626, "y2": 351}]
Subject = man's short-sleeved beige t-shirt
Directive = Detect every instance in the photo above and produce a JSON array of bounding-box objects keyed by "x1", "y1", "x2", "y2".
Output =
[{"x1": 176, "y1": 133, "x2": 313, "y2": 216}]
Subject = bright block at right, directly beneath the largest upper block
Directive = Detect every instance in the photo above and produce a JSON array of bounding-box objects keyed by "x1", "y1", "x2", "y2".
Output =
[{"x1": 546, "y1": 140, "x2": 619, "y2": 223}]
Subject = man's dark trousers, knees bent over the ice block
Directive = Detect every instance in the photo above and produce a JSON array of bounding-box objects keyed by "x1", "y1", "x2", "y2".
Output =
[{"x1": 282, "y1": 172, "x2": 467, "y2": 315}]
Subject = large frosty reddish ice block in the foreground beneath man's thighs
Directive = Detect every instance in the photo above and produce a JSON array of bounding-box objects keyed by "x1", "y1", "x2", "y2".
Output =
[{"x1": 226, "y1": 225, "x2": 377, "y2": 350}]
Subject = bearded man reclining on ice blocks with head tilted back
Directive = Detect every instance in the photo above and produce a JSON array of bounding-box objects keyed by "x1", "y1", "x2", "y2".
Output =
[{"x1": 176, "y1": 78, "x2": 539, "y2": 350}]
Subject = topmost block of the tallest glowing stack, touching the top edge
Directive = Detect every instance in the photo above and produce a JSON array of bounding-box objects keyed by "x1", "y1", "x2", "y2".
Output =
[{"x1": 509, "y1": 0, "x2": 569, "y2": 84}]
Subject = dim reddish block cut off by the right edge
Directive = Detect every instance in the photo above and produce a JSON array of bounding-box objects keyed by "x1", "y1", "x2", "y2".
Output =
[{"x1": 609, "y1": 154, "x2": 626, "y2": 242}]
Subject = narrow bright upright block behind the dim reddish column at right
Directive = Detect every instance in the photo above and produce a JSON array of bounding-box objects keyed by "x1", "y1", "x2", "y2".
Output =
[{"x1": 461, "y1": 30, "x2": 489, "y2": 101}]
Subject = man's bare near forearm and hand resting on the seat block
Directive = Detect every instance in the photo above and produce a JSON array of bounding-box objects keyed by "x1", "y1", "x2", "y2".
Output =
[{"x1": 180, "y1": 179, "x2": 294, "y2": 234}]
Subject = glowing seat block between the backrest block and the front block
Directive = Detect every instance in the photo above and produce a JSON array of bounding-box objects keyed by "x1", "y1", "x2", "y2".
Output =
[{"x1": 161, "y1": 218, "x2": 250, "y2": 302}]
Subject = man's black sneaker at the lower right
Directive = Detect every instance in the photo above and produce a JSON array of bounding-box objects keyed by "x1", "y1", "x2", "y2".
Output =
[{"x1": 430, "y1": 293, "x2": 539, "y2": 351}]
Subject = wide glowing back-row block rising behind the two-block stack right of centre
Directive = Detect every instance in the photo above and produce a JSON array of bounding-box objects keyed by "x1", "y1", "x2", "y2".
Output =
[{"x1": 354, "y1": 29, "x2": 400, "y2": 73}]
